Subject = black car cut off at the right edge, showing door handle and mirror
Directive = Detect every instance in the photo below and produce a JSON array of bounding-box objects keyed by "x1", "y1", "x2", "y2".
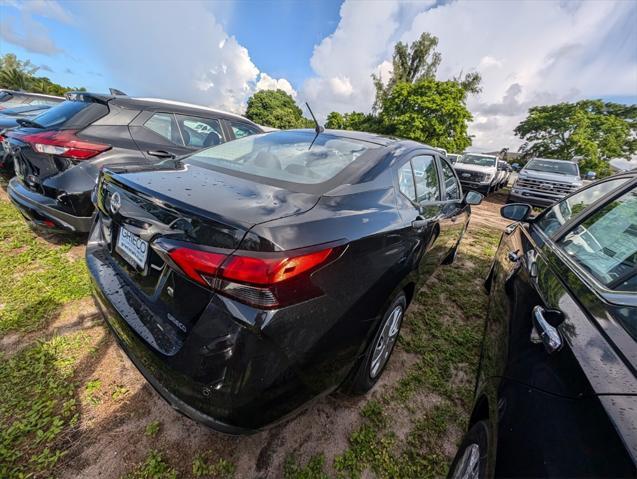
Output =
[{"x1": 450, "y1": 172, "x2": 637, "y2": 478}]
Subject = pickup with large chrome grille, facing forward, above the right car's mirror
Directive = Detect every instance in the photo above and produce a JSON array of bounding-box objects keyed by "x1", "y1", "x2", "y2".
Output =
[{"x1": 508, "y1": 158, "x2": 582, "y2": 206}]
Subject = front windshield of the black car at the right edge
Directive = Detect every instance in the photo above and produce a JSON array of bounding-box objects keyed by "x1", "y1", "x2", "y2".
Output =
[{"x1": 535, "y1": 178, "x2": 628, "y2": 236}]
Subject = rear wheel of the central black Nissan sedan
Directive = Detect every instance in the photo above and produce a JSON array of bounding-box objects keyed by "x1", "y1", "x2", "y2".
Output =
[{"x1": 343, "y1": 291, "x2": 407, "y2": 395}]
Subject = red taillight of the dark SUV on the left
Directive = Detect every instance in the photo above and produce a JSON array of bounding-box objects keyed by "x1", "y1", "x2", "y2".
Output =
[{"x1": 15, "y1": 130, "x2": 111, "y2": 160}]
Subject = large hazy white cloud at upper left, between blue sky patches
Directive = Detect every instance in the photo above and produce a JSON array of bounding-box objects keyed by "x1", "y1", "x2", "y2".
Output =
[{"x1": 78, "y1": 1, "x2": 294, "y2": 112}]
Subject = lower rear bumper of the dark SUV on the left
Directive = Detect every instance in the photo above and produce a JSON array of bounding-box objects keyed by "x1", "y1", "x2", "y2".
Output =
[{"x1": 7, "y1": 178, "x2": 93, "y2": 233}]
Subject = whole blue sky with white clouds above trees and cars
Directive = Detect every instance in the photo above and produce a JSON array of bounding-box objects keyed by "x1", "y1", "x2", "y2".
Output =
[{"x1": 0, "y1": 0, "x2": 637, "y2": 149}]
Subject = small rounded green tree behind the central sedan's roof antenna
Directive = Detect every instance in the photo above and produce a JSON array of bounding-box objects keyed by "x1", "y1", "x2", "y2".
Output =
[{"x1": 246, "y1": 90, "x2": 314, "y2": 129}]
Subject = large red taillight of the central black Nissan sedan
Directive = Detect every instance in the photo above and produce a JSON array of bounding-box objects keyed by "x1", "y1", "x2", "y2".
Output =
[{"x1": 168, "y1": 247, "x2": 334, "y2": 309}]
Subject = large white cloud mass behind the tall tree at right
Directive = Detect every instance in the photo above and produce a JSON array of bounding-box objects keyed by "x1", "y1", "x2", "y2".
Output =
[{"x1": 301, "y1": 1, "x2": 637, "y2": 149}]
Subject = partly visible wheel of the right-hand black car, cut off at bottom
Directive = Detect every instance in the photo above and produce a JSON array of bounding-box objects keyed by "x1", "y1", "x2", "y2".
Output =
[{"x1": 447, "y1": 420, "x2": 489, "y2": 479}]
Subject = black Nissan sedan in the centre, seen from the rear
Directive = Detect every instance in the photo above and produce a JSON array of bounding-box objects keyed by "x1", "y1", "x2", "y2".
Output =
[{"x1": 86, "y1": 130, "x2": 482, "y2": 433}]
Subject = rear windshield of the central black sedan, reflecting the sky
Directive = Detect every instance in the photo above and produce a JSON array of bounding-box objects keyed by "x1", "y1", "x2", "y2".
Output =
[{"x1": 185, "y1": 131, "x2": 378, "y2": 184}]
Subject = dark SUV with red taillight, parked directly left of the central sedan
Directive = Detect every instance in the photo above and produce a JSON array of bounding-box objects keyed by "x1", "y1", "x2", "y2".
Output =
[{"x1": 3, "y1": 92, "x2": 261, "y2": 233}]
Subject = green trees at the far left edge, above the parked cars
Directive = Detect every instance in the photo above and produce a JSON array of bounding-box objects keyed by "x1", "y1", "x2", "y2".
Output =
[{"x1": 0, "y1": 53, "x2": 86, "y2": 96}]
